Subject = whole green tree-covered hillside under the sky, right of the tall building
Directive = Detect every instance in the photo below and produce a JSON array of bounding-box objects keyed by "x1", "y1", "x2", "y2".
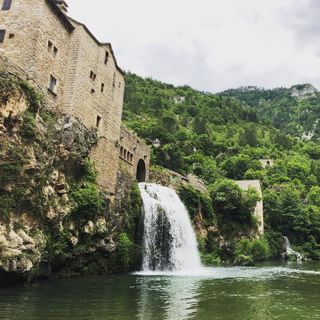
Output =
[{"x1": 124, "y1": 73, "x2": 320, "y2": 258}]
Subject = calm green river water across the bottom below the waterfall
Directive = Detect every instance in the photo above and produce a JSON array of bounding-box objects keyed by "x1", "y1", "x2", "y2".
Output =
[{"x1": 0, "y1": 262, "x2": 320, "y2": 320}]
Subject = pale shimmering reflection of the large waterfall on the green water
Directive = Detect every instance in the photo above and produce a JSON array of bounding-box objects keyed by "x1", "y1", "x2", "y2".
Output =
[{"x1": 137, "y1": 277, "x2": 200, "y2": 320}]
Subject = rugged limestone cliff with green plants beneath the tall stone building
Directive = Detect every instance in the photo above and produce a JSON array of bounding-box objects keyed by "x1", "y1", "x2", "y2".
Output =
[{"x1": 0, "y1": 72, "x2": 140, "y2": 282}]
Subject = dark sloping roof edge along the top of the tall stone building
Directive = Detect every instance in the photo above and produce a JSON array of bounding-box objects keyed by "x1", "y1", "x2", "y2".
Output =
[{"x1": 45, "y1": 0, "x2": 124, "y2": 75}]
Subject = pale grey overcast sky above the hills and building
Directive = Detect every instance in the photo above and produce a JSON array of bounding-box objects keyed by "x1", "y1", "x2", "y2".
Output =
[{"x1": 67, "y1": 0, "x2": 320, "y2": 92}]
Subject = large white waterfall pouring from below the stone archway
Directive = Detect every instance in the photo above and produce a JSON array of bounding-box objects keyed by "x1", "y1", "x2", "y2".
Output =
[{"x1": 139, "y1": 183, "x2": 201, "y2": 272}]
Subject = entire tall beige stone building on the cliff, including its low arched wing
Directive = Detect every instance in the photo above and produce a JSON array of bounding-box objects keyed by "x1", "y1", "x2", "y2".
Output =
[{"x1": 0, "y1": 0, "x2": 150, "y2": 194}]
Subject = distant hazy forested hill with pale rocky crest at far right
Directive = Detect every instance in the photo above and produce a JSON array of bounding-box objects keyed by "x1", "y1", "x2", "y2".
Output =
[{"x1": 220, "y1": 84, "x2": 320, "y2": 140}]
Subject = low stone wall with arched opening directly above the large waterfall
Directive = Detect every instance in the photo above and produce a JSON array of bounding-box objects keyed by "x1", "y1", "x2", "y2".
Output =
[{"x1": 119, "y1": 126, "x2": 151, "y2": 181}]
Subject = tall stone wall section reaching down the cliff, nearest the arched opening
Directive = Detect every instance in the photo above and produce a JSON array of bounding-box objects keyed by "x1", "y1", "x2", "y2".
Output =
[{"x1": 64, "y1": 20, "x2": 124, "y2": 193}]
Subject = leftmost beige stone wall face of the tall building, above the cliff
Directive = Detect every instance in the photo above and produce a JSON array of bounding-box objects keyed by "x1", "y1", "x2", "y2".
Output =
[{"x1": 0, "y1": 0, "x2": 70, "y2": 107}]
